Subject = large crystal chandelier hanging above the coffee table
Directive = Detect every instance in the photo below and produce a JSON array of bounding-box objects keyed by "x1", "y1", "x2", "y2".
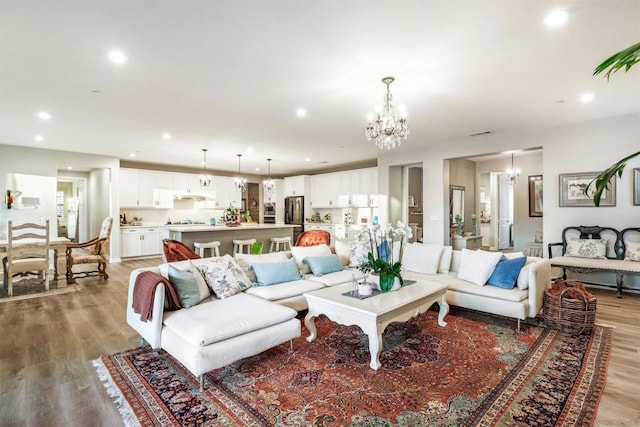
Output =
[{"x1": 365, "y1": 77, "x2": 409, "y2": 150}]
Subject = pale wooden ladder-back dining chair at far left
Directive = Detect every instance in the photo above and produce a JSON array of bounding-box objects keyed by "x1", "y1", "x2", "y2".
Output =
[{"x1": 2, "y1": 220, "x2": 49, "y2": 296}]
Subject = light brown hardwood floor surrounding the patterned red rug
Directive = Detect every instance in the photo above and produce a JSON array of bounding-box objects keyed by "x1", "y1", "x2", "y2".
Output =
[{"x1": 0, "y1": 258, "x2": 640, "y2": 426}]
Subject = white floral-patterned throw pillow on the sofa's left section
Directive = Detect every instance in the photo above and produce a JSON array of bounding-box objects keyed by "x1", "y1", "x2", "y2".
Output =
[{"x1": 198, "y1": 254, "x2": 251, "y2": 298}]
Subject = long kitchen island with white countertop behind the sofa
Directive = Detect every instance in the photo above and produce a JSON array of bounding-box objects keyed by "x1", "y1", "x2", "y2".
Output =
[{"x1": 162, "y1": 224, "x2": 299, "y2": 256}]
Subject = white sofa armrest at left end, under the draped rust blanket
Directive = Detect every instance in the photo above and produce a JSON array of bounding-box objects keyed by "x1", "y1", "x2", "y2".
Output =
[{"x1": 127, "y1": 267, "x2": 164, "y2": 349}]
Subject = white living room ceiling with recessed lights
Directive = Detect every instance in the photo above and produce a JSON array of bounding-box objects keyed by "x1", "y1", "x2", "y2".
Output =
[{"x1": 0, "y1": 0, "x2": 640, "y2": 175}]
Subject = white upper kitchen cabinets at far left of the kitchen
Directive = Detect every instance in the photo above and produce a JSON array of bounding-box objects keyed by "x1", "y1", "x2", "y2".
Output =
[{"x1": 120, "y1": 168, "x2": 173, "y2": 209}]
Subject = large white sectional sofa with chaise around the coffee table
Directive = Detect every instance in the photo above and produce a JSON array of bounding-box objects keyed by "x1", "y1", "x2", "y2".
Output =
[{"x1": 127, "y1": 243, "x2": 551, "y2": 387}]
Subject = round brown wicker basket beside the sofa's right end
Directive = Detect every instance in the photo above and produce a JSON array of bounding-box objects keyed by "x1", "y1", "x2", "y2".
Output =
[{"x1": 544, "y1": 281, "x2": 597, "y2": 335}]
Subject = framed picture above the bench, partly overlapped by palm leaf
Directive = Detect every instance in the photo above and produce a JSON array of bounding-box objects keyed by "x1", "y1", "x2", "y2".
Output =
[{"x1": 559, "y1": 172, "x2": 616, "y2": 207}]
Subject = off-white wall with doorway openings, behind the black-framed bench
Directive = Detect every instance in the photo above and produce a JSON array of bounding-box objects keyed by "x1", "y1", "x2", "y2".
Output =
[{"x1": 378, "y1": 113, "x2": 640, "y2": 289}]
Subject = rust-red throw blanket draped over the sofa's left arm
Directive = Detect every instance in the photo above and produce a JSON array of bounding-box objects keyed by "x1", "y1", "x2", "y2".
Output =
[{"x1": 131, "y1": 271, "x2": 182, "y2": 322}]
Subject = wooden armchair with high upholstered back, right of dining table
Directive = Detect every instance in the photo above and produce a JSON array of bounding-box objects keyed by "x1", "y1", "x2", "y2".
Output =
[{"x1": 66, "y1": 217, "x2": 113, "y2": 284}]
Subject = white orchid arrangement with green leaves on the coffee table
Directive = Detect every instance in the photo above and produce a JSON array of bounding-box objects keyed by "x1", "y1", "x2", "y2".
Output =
[{"x1": 358, "y1": 221, "x2": 413, "y2": 292}]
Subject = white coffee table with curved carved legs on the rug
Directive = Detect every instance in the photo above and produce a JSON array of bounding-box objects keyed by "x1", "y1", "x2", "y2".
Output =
[{"x1": 304, "y1": 280, "x2": 449, "y2": 370}]
